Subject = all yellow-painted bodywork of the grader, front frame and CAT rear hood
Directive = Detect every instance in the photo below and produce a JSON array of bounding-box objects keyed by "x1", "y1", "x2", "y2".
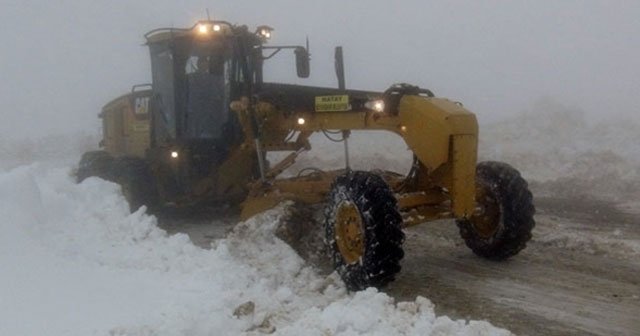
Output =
[{"x1": 101, "y1": 90, "x2": 478, "y2": 225}]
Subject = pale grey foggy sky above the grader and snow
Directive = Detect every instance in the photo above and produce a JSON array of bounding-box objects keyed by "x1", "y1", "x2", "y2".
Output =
[{"x1": 0, "y1": 0, "x2": 640, "y2": 138}]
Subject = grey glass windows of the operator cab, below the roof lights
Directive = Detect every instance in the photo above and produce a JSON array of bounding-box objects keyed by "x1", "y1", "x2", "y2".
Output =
[{"x1": 150, "y1": 39, "x2": 238, "y2": 142}]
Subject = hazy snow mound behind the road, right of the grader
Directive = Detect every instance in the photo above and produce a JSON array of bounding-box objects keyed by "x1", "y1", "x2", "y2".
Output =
[{"x1": 479, "y1": 101, "x2": 640, "y2": 200}]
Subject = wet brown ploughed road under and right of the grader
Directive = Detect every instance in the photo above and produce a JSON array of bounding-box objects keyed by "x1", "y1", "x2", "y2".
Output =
[{"x1": 161, "y1": 198, "x2": 640, "y2": 336}]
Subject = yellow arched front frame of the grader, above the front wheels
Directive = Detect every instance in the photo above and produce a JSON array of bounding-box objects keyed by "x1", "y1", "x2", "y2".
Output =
[{"x1": 238, "y1": 95, "x2": 478, "y2": 226}]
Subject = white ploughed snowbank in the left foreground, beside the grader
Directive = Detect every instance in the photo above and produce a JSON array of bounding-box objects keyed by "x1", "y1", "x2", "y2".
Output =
[{"x1": 0, "y1": 164, "x2": 509, "y2": 335}]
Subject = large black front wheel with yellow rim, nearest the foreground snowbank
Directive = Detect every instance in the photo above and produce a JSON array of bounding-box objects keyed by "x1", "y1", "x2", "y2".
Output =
[{"x1": 324, "y1": 172, "x2": 404, "y2": 291}]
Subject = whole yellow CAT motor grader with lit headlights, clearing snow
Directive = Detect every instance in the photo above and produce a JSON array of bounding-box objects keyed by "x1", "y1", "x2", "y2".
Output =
[{"x1": 77, "y1": 20, "x2": 534, "y2": 290}]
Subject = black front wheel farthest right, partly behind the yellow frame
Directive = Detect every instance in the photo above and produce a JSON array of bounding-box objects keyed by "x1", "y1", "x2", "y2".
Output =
[{"x1": 456, "y1": 161, "x2": 535, "y2": 260}]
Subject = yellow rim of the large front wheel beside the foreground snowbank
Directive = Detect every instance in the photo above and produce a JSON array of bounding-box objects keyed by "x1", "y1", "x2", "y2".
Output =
[{"x1": 334, "y1": 202, "x2": 364, "y2": 264}]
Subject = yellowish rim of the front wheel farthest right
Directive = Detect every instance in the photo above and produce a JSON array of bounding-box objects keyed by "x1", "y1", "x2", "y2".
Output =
[{"x1": 469, "y1": 185, "x2": 502, "y2": 239}]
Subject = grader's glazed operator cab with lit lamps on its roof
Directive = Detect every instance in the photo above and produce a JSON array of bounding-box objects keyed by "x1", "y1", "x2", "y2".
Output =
[{"x1": 146, "y1": 22, "x2": 259, "y2": 149}]
